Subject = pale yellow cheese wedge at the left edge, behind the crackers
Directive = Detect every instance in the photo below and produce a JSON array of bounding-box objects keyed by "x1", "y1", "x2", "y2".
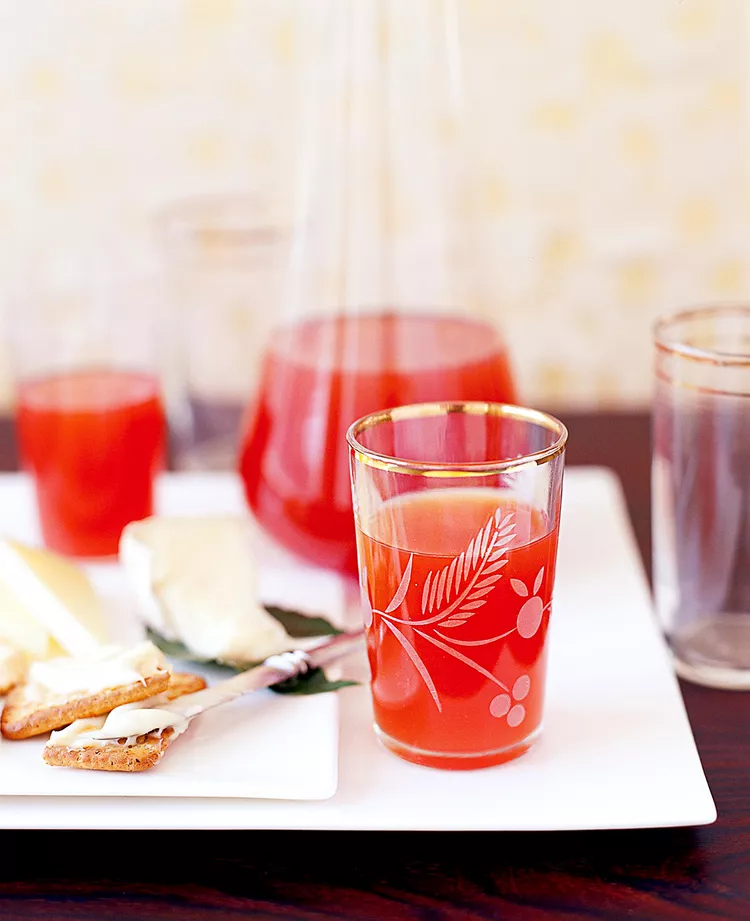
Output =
[{"x1": 0, "y1": 538, "x2": 108, "y2": 660}]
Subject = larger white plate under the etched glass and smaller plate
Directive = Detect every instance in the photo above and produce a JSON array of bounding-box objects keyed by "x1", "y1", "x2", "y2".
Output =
[{"x1": 0, "y1": 467, "x2": 716, "y2": 831}]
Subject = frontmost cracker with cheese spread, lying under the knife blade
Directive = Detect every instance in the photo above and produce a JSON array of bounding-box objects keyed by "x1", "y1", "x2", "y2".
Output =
[{"x1": 42, "y1": 672, "x2": 206, "y2": 773}]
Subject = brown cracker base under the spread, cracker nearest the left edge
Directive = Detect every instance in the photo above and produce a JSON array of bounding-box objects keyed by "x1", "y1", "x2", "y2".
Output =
[{"x1": 0, "y1": 669, "x2": 170, "y2": 739}]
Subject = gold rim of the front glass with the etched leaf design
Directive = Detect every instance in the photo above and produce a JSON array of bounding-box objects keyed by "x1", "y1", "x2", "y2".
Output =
[{"x1": 346, "y1": 401, "x2": 568, "y2": 475}]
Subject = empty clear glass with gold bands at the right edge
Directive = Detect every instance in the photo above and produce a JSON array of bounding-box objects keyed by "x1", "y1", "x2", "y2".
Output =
[{"x1": 652, "y1": 306, "x2": 750, "y2": 688}]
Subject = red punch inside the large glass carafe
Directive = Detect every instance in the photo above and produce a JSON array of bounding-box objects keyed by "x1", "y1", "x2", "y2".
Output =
[{"x1": 240, "y1": 313, "x2": 515, "y2": 575}]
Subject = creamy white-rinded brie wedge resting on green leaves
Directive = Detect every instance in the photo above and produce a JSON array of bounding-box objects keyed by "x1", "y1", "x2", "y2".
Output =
[{"x1": 120, "y1": 515, "x2": 295, "y2": 662}]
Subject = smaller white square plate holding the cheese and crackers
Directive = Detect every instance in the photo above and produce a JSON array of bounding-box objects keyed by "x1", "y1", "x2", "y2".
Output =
[{"x1": 0, "y1": 474, "x2": 344, "y2": 800}]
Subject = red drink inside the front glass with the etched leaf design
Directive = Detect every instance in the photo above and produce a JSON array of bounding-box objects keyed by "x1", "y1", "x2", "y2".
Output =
[{"x1": 359, "y1": 489, "x2": 557, "y2": 768}]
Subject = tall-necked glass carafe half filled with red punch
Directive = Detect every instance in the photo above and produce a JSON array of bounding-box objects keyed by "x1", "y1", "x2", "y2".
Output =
[{"x1": 239, "y1": 0, "x2": 517, "y2": 576}]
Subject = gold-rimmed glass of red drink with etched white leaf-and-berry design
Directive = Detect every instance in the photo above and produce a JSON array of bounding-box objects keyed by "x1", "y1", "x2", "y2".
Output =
[{"x1": 348, "y1": 403, "x2": 567, "y2": 769}]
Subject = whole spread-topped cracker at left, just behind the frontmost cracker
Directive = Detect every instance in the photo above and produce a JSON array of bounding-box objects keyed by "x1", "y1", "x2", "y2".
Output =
[{"x1": 0, "y1": 641, "x2": 171, "y2": 739}]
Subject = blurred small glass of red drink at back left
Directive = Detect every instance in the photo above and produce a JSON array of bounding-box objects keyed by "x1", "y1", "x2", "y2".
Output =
[{"x1": 11, "y1": 262, "x2": 167, "y2": 558}]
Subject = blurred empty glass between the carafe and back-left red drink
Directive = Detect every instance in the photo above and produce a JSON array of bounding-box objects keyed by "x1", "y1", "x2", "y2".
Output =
[{"x1": 155, "y1": 194, "x2": 288, "y2": 470}]
